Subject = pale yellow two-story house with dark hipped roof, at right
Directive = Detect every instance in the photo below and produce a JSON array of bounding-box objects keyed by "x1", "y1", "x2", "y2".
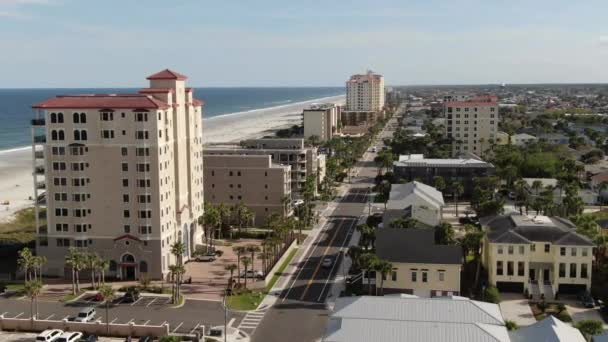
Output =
[{"x1": 481, "y1": 215, "x2": 594, "y2": 299}]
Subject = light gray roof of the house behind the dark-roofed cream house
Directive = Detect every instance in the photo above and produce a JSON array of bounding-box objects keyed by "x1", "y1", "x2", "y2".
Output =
[{"x1": 386, "y1": 181, "x2": 445, "y2": 209}]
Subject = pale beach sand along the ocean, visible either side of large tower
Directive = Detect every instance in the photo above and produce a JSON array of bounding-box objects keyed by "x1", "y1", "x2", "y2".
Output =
[{"x1": 0, "y1": 95, "x2": 345, "y2": 222}]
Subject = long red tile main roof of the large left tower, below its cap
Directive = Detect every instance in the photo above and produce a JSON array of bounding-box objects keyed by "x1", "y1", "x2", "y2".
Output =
[{"x1": 32, "y1": 94, "x2": 169, "y2": 109}]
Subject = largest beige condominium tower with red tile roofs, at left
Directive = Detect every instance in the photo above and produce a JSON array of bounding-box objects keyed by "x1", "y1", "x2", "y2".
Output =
[{"x1": 32, "y1": 70, "x2": 203, "y2": 280}]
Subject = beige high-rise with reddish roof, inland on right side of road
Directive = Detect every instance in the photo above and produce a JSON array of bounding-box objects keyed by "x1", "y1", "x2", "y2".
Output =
[{"x1": 443, "y1": 95, "x2": 499, "y2": 158}]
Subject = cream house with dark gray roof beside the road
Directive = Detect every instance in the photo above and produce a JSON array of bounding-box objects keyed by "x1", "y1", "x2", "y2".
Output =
[{"x1": 375, "y1": 227, "x2": 463, "y2": 297}]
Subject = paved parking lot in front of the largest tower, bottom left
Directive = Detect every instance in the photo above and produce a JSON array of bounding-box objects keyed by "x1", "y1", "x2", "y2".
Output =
[{"x1": 0, "y1": 295, "x2": 244, "y2": 334}]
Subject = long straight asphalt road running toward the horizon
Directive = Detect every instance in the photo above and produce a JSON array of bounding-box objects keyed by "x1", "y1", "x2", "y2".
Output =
[{"x1": 252, "y1": 115, "x2": 396, "y2": 342}]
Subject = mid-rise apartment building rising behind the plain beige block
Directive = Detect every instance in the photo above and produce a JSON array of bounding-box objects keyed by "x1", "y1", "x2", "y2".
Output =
[{"x1": 204, "y1": 138, "x2": 325, "y2": 199}]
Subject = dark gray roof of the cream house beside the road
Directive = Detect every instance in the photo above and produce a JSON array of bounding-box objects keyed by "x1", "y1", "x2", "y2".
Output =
[{"x1": 376, "y1": 227, "x2": 462, "y2": 264}]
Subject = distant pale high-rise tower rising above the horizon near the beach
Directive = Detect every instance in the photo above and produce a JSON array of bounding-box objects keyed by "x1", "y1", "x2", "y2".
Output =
[{"x1": 346, "y1": 71, "x2": 385, "y2": 112}]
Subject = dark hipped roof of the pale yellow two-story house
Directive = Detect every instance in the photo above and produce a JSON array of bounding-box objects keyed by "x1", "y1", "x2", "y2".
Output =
[{"x1": 480, "y1": 214, "x2": 594, "y2": 246}]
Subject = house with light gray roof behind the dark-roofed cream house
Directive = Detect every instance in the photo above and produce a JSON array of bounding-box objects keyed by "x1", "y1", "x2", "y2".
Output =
[{"x1": 382, "y1": 181, "x2": 445, "y2": 227}]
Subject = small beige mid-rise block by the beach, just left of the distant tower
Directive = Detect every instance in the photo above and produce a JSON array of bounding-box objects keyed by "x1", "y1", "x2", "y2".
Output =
[{"x1": 302, "y1": 103, "x2": 342, "y2": 141}]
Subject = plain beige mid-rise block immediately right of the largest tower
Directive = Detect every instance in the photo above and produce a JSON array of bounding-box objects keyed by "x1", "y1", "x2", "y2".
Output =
[{"x1": 203, "y1": 154, "x2": 292, "y2": 226}]
